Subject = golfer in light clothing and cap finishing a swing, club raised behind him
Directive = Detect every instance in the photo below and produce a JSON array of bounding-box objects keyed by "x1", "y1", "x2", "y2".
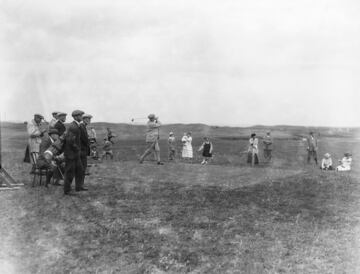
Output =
[{"x1": 140, "y1": 114, "x2": 164, "y2": 165}]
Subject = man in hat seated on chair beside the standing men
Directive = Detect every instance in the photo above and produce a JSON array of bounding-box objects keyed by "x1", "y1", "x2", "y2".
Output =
[{"x1": 37, "y1": 128, "x2": 62, "y2": 186}]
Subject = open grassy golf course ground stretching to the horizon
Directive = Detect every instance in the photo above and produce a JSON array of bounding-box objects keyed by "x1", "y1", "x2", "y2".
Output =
[{"x1": 0, "y1": 124, "x2": 360, "y2": 273}]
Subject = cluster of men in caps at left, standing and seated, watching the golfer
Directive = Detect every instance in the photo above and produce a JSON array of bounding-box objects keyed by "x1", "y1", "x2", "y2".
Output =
[{"x1": 25, "y1": 110, "x2": 96, "y2": 195}]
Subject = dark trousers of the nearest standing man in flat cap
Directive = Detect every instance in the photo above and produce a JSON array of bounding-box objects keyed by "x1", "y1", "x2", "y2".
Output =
[{"x1": 64, "y1": 158, "x2": 84, "y2": 193}]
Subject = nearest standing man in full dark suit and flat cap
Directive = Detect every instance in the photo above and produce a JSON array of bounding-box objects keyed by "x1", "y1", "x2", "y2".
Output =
[{"x1": 64, "y1": 110, "x2": 87, "y2": 195}]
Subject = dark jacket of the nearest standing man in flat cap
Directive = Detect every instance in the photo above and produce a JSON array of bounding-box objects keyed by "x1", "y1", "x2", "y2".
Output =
[{"x1": 64, "y1": 121, "x2": 81, "y2": 160}]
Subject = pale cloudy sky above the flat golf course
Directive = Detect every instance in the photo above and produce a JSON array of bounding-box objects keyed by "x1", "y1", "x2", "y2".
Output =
[{"x1": 0, "y1": 0, "x2": 360, "y2": 127}]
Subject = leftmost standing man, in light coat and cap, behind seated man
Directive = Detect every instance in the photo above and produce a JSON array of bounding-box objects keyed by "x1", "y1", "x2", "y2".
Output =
[{"x1": 27, "y1": 113, "x2": 47, "y2": 164}]
